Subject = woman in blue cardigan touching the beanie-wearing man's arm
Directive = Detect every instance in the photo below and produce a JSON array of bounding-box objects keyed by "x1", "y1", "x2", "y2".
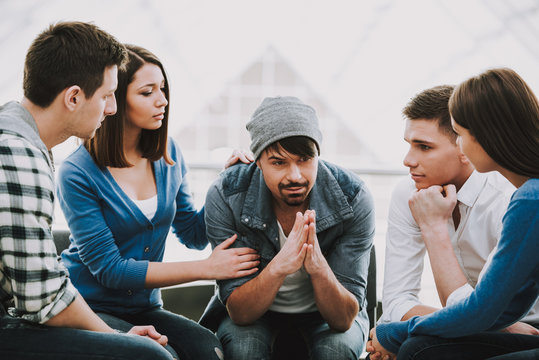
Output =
[{"x1": 58, "y1": 45, "x2": 259, "y2": 360}]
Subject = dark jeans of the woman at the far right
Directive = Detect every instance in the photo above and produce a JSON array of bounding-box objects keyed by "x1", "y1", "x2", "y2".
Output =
[{"x1": 397, "y1": 332, "x2": 539, "y2": 360}]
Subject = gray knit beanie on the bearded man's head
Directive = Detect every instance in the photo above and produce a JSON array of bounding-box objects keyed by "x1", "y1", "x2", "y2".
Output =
[{"x1": 246, "y1": 96, "x2": 322, "y2": 159}]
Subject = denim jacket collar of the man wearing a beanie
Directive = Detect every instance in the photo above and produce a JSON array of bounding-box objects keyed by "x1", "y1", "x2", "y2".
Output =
[{"x1": 240, "y1": 160, "x2": 353, "y2": 233}]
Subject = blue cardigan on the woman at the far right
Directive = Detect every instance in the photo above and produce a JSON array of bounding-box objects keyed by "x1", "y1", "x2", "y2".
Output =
[{"x1": 376, "y1": 179, "x2": 539, "y2": 353}]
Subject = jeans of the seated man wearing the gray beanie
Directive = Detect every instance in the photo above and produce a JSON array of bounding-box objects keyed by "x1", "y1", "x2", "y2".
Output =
[{"x1": 217, "y1": 311, "x2": 365, "y2": 360}]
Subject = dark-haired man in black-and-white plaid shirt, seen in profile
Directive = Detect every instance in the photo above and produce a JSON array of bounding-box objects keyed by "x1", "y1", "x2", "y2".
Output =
[{"x1": 0, "y1": 22, "x2": 171, "y2": 359}]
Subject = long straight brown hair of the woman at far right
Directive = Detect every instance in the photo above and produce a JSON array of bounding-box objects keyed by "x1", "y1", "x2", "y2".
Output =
[{"x1": 449, "y1": 68, "x2": 539, "y2": 178}]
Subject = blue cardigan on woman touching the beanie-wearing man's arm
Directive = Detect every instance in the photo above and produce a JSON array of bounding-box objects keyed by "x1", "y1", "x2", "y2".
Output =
[{"x1": 57, "y1": 139, "x2": 208, "y2": 314}]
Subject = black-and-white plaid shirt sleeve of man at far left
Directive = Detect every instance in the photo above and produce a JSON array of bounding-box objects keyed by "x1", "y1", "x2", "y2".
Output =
[{"x1": 0, "y1": 130, "x2": 77, "y2": 323}]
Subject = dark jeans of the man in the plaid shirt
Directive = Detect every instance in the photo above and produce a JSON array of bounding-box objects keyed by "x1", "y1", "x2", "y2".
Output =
[{"x1": 0, "y1": 315, "x2": 172, "y2": 360}]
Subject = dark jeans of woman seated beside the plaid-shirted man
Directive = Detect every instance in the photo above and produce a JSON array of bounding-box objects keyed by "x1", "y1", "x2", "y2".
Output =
[{"x1": 97, "y1": 308, "x2": 223, "y2": 360}]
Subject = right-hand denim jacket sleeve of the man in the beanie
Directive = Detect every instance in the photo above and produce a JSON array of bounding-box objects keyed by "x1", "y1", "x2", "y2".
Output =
[{"x1": 326, "y1": 186, "x2": 375, "y2": 310}]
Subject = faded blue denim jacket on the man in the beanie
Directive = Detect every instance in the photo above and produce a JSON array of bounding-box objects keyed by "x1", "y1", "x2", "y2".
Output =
[{"x1": 205, "y1": 160, "x2": 375, "y2": 326}]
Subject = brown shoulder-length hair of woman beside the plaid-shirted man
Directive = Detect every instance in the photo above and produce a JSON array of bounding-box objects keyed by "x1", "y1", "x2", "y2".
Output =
[{"x1": 84, "y1": 45, "x2": 174, "y2": 168}]
